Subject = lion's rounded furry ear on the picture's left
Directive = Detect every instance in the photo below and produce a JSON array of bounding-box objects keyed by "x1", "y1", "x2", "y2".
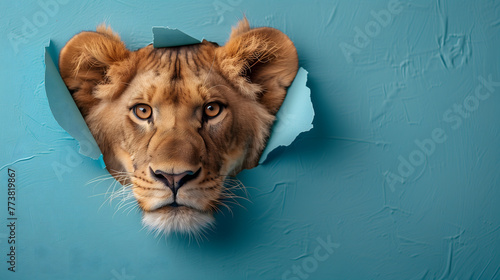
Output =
[{"x1": 59, "y1": 25, "x2": 130, "y2": 91}]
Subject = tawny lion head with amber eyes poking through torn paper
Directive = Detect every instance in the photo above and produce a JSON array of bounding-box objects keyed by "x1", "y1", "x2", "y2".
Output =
[{"x1": 59, "y1": 19, "x2": 298, "y2": 233}]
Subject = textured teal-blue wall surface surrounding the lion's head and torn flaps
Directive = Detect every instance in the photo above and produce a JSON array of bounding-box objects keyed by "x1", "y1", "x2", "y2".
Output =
[{"x1": 0, "y1": 0, "x2": 500, "y2": 280}]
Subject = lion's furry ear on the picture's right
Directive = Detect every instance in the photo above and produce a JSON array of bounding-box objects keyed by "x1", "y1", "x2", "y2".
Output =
[{"x1": 217, "y1": 18, "x2": 298, "y2": 114}]
